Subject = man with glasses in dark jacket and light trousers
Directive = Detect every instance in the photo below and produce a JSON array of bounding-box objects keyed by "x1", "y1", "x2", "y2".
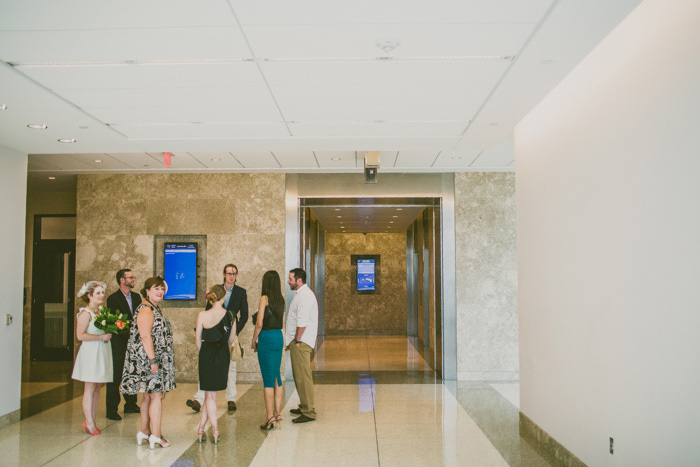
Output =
[{"x1": 186, "y1": 264, "x2": 248, "y2": 412}]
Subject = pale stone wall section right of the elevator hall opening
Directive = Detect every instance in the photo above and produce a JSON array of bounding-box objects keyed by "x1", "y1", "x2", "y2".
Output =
[{"x1": 455, "y1": 172, "x2": 519, "y2": 380}]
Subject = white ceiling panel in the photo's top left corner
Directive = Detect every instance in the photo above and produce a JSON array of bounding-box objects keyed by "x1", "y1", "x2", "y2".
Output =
[{"x1": 0, "y1": 0, "x2": 236, "y2": 31}]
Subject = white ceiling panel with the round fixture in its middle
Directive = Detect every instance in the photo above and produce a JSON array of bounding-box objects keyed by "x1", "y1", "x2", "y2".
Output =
[{"x1": 245, "y1": 24, "x2": 535, "y2": 58}]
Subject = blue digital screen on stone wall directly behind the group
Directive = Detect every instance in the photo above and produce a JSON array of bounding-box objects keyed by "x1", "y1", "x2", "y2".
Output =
[{"x1": 163, "y1": 243, "x2": 197, "y2": 300}]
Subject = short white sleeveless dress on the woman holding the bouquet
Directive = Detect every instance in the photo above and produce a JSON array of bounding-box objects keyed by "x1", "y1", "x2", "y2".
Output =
[{"x1": 71, "y1": 308, "x2": 113, "y2": 383}]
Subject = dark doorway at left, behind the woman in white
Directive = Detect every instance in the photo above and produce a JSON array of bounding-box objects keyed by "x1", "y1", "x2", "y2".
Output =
[{"x1": 30, "y1": 215, "x2": 75, "y2": 361}]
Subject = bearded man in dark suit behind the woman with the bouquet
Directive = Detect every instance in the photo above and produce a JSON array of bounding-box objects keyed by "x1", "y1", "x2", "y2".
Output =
[{"x1": 106, "y1": 269, "x2": 141, "y2": 420}]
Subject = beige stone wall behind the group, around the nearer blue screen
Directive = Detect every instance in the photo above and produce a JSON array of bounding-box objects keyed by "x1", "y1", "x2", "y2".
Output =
[{"x1": 76, "y1": 174, "x2": 285, "y2": 381}]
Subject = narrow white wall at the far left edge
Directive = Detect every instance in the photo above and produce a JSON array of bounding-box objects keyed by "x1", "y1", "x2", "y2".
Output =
[{"x1": 0, "y1": 145, "x2": 27, "y2": 417}]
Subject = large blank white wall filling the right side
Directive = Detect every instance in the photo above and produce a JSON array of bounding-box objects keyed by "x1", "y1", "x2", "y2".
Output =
[{"x1": 516, "y1": 0, "x2": 700, "y2": 466}]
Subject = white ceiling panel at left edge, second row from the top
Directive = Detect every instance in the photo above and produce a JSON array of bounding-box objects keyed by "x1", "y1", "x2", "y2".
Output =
[{"x1": 0, "y1": 25, "x2": 251, "y2": 62}]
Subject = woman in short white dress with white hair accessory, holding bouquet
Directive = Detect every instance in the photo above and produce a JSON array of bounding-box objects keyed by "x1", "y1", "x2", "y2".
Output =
[{"x1": 72, "y1": 281, "x2": 112, "y2": 435}]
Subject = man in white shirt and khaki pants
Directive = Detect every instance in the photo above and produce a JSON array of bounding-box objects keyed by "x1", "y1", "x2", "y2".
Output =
[{"x1": 284, "y1": 268, "x2": 318, "y2": 423}]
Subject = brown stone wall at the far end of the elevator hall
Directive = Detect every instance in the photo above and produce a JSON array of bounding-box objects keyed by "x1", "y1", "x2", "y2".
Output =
[{"x1": 325, "y1": 233, "x2": 406, "y2": 336}]
